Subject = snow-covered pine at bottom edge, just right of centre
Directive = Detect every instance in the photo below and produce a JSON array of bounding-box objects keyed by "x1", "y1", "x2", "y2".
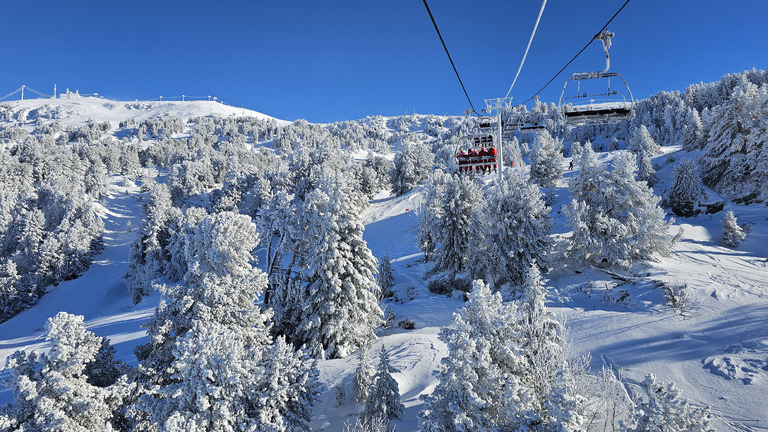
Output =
[{"x1": 419, "y1": 281, "x2": 533, "y2": 432}]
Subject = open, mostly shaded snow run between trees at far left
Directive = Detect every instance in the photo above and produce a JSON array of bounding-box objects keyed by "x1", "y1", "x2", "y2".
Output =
[{"x1": 0, "y1": 177, "x2": 158, "y2": 405}]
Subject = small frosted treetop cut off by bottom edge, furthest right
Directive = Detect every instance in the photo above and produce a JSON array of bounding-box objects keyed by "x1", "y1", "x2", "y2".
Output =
[{"x1": 634, "y1": 374, "x2": 715, "y2": 432}]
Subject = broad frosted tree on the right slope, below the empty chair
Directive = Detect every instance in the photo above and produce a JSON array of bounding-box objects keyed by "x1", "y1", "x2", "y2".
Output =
[{"x1": 564, "y1": 145, "x2": 680, "y2": 266}]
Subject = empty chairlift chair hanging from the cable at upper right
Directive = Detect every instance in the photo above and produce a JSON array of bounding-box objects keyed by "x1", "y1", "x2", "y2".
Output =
[{"x1": 558, "y1": 30, "x2": 635, "y2": 126}]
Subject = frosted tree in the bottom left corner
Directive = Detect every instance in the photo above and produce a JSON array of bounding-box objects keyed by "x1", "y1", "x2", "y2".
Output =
[{"x1": 1, "y1": 312, "x2": 122, "y2": 431}]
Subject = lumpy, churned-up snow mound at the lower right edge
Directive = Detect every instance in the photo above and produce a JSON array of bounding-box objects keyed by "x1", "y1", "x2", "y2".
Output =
[{"x1": 702, "y1": 338, "x2": 768, "y2": 384}]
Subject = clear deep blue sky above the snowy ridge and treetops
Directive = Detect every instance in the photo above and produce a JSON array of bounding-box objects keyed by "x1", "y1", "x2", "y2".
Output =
[{"x1": 0, "y1": 0, "x2": 768, "y2": 122}]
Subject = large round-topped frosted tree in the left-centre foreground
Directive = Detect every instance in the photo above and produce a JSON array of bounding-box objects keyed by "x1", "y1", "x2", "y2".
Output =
[{"x1": 137, "y1": 212, "x2": 316, "y2": 431}]
